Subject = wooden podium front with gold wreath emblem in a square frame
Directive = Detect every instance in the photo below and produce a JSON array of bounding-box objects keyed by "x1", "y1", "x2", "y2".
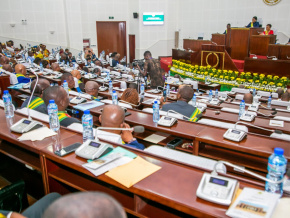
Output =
[{"x1": 200, "y1": 44, "x2": 238, "y2": 71}]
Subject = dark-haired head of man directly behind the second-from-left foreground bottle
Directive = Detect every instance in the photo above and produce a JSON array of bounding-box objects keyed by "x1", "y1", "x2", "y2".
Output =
[{"x1": 42, "y1": 86, "x2": 69, "y2": 111}]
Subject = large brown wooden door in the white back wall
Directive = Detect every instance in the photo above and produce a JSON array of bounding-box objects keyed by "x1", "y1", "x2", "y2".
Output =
[{"x1": 96, "y1": 21, "x2": 128, "y2": 61}]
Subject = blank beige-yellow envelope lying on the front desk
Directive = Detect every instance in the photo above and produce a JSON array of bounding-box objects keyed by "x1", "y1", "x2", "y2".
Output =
[{"x1": 105, "y1": 156, "x2": 161, "y2": 188}]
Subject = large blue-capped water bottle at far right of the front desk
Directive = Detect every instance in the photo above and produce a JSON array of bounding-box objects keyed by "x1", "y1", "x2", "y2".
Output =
[{"x1": 265, "y1": 148, "x2": 287, "y2": 196}]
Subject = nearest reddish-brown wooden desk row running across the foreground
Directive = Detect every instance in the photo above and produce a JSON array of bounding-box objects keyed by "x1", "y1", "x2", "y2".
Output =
[{"x1": 0, "y1": 109, "x2": 270, "y2": 217}]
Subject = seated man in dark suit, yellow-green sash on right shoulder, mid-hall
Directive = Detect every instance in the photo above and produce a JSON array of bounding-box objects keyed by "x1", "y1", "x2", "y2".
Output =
[{"x1": 160, "y1": 85, "x2": 202, "y2": 122}]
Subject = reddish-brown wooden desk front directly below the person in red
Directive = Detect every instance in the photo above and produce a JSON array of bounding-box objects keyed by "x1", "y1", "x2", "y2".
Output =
[{"x1": 249, "y1": 35, "x2": 276, "y2": 56}]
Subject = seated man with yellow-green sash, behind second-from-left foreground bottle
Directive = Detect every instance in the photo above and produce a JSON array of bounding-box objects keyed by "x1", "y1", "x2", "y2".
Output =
[{"x1": 43, "y1": 86, "x2": 81, "y2": 127}]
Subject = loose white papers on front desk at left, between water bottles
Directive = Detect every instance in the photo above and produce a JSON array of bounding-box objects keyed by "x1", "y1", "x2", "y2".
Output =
[{"x1": 18, "y1": 127, "x2": 56, "y2": 141}]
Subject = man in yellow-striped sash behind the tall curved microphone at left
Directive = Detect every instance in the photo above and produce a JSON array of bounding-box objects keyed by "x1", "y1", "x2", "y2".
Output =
[{"x1": 21, "y1": 79, "x2": 50, "y2": 114}]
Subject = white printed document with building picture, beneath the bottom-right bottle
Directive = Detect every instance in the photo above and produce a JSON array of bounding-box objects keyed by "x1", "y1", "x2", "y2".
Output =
[{"x1": 226, "y1": 188, "x2": 280, "y2": 218}]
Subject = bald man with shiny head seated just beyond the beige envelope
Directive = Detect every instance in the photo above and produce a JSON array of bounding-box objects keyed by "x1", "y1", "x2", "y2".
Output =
[{"x1": 99, "y1": 105, "x2": 144, "y2": 150}]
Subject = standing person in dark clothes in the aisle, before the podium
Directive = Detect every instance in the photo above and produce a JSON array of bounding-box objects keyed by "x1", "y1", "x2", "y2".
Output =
[{"x1": 137, "y1": 51, "x2": 164, "y2": 89}]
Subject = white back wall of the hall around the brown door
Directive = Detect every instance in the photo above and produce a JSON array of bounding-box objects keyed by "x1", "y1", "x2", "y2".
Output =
[{"x1": 0, "y1": 0, "x2": 290, "y2": 58}]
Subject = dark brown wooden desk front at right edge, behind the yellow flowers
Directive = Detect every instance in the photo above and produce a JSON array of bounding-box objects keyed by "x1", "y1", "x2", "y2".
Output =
[{"x1": 244, "y1": 58, "x2": 290, "y2": 77}]
